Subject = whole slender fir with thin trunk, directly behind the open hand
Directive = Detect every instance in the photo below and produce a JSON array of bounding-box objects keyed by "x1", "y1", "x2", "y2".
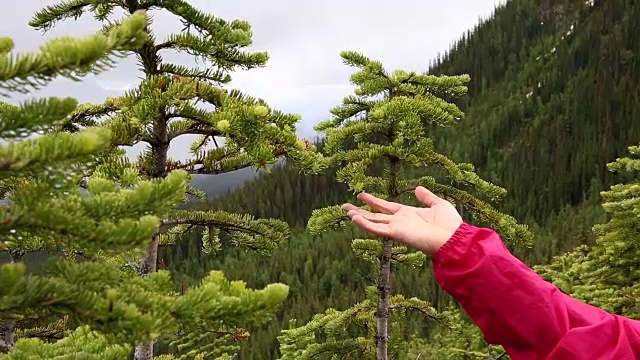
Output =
[{"x1": 280, "y1": 52, "x2": 532, "y2": 360}]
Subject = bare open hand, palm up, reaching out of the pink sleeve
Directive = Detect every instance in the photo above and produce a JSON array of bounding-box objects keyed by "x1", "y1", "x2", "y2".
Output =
[{"x1": 342, "y1": 186, "x2": 462, "y2": 254}]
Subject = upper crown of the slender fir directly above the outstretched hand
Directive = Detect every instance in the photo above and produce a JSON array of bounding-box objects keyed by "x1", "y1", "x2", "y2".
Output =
[{"x1": 309, "y1": 52, "x2": 532, "y2": 244}]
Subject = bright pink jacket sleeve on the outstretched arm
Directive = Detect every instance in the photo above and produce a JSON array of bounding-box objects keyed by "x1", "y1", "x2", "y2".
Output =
[{"x1": 433, "y1": 224, "x2": 640, "y2": 360}]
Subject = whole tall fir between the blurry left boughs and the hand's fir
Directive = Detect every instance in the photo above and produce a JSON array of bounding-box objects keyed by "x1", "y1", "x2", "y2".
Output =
[{"x1": 30, "y1": 0, "x2": 323, "y2": 360}]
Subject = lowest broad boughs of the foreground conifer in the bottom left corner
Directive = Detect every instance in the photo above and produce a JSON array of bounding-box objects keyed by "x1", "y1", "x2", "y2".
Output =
[{"x1": 0, "y1": 260, "x2": 288, "y2": 359}]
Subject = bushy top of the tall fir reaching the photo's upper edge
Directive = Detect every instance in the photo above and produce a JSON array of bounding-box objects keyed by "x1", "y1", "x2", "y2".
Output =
[{"x1": 30, "y1": 0, "x2": 322, "y2": 177}]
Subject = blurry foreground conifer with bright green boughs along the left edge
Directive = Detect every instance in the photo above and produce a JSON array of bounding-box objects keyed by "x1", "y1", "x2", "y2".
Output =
[{"x1": 0, "y1": 13, "x2": 296, "y2": 359}]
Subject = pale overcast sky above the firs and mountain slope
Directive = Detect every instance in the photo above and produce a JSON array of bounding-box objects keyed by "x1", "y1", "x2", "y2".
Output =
[{"x1": 0, "y1": 0, "x2": 503, "y2": 158}]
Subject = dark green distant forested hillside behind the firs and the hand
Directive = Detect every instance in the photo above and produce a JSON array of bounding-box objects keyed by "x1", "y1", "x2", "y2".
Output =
[{"x1": 162, "y1": 0, "x2": 640, "y2": 359}]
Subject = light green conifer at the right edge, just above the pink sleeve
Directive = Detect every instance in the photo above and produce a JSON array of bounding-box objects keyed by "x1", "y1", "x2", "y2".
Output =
[{"x1": 536, "y1": 146, "x2": 640, "y2": 319}]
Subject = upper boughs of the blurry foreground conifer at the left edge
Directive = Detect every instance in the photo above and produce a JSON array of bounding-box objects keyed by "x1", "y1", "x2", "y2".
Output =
[{"x1": 0, "y1": 14, "x2": 169, "y2": 252}]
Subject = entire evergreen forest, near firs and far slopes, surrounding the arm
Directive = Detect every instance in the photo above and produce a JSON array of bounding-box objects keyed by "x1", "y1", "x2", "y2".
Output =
[{"x1": 0, "y1": 0, "x2": 640, "y2": 360}]
